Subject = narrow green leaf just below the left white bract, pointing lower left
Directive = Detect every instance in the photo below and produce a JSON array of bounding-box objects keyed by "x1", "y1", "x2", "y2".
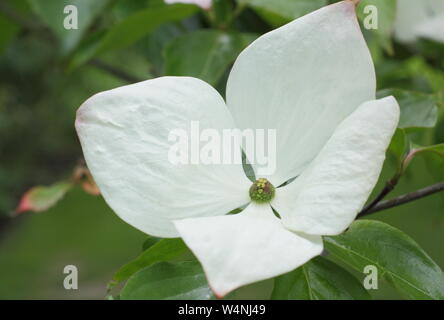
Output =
[{"x1": 113, "y1": 239, "x2": 188, "y2": 284}]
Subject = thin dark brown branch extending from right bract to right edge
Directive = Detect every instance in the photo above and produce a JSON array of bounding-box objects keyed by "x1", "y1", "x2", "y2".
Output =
[{"x1": 357, "y1": 181, "x2": 444, "y2": 218}]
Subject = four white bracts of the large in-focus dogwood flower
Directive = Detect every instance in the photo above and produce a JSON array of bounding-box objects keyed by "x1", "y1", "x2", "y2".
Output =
[{"x1": 76, "y1": 1, "x2": 399, "y2": 296}]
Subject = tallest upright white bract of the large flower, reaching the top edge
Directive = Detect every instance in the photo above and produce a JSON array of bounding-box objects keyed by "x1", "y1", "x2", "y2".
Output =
[{"x1": 227, "y1": 1, "x2": 376, "y2": 186}]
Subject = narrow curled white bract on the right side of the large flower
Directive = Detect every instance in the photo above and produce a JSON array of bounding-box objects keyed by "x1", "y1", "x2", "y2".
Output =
[{"x1": 272, "y1": 97, "x2": 399, "y2": 235}]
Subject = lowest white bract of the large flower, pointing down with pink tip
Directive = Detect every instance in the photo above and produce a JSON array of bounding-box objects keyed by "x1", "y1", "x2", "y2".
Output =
[{"x1": 175, "y1": 203, "x2": 323, "y2": 297}]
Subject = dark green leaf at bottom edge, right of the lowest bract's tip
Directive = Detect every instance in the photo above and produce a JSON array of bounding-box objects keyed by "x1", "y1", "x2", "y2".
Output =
[{"x1": 271, "y1": 257, "x2": 370, "y2": 300}]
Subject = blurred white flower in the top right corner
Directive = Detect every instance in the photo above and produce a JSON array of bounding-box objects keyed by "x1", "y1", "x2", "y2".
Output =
[{"x1": 395, "y1": 0, "x2": 444, "y2": 43}]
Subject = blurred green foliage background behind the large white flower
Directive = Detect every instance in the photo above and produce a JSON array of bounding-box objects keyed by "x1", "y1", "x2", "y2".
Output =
[{"x1": 0, "y1": 0, "x2": 444, "y2": 299}]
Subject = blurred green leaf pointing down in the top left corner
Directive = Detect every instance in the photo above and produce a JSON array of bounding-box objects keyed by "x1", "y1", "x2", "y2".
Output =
[{"x1": 28, "y1": 0, "x2": 108, "y2": 53}]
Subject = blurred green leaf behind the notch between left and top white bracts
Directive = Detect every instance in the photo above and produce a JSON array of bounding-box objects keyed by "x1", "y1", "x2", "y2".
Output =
[{"x1": 165, "y1": 30, "x2": 255, "y2": 85}]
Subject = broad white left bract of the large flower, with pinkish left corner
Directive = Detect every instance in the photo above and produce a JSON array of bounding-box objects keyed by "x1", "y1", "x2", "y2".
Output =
[{"x1": 76, "y1": 77, "x2": 251, "y2": 237}]
